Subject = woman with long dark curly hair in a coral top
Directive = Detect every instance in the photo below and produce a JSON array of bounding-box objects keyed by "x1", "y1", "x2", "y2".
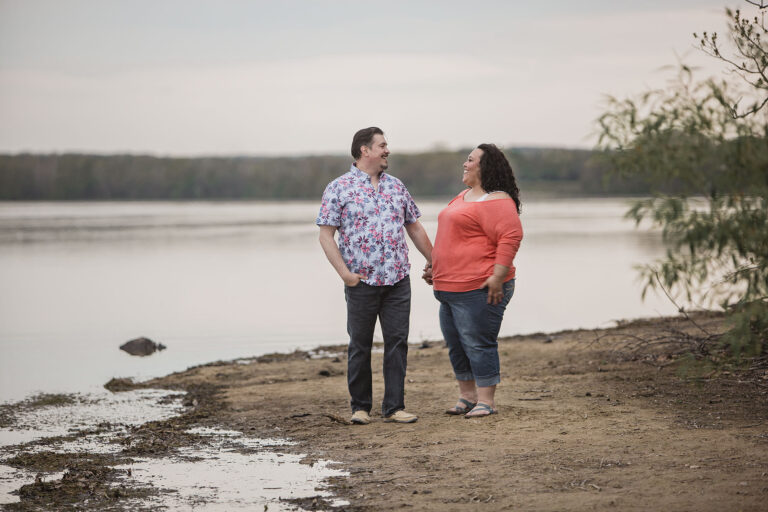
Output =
[{"x1": 425, "y1": 144, "x2": 523, "y2": 418}]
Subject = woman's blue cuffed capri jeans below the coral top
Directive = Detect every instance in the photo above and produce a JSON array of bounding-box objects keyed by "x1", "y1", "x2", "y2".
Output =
[{"x1": 435, "y1": 279, "x2": 515, "y2": 387}]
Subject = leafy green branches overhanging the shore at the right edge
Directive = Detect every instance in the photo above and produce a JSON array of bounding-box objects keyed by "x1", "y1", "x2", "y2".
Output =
[{"x1": 597, "y1": 2, "x2": 768, "y2": 368}]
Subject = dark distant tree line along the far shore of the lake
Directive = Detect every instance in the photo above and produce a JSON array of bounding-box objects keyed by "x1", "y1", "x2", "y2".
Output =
[{"x1": 0, "y1": 148, "x2": 647, "y2": 200}]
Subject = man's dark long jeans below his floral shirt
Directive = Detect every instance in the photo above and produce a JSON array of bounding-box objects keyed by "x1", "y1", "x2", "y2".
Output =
[{"x1": 344, "y1": 276, "x2": 411, "y2": 416}]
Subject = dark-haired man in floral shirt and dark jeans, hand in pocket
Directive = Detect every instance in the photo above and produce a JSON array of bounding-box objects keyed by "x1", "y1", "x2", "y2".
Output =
[{"x1": 316, "y1": 126, "x2": 432, "y2": 425}]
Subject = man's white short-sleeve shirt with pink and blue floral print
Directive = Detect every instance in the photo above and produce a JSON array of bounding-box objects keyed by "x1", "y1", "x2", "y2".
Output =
[{"x1": 315, "y1": 164, "x2": 421, "y2": 286}]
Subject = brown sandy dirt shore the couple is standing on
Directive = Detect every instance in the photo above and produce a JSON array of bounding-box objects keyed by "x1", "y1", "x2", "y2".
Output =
[{"x1": 1, "y1": 314, "x2": 768, "y2": 511}]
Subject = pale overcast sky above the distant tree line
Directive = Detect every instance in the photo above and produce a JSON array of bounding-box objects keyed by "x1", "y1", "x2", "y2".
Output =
[{"x1": 0, "y1": 0, "x2": 736, "y2": 156}]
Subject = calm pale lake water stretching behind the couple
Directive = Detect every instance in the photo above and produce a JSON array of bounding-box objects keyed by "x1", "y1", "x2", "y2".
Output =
[{"x1": 0, "y1": 199, "x2": 674, "y2": 401}]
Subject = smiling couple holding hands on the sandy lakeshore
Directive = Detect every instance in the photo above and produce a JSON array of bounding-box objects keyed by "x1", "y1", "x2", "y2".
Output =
[{"x1": 316, "y1": 127, "x2": 523, "y2": 424}]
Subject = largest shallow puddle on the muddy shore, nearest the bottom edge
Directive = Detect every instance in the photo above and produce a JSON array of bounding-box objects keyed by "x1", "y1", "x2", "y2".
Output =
[{"x1": 118, "y1": 429, "x2": 349, "y2": 511}]
